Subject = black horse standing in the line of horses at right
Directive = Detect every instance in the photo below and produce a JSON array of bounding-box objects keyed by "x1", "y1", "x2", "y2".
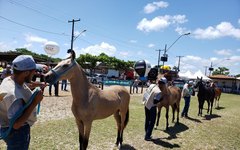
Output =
[{"x1": 194, "y1": 78, "x2": 215, "y2": 116}]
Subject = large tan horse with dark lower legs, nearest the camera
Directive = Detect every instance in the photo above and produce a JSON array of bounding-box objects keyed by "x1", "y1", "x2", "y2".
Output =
[{"x1": 46, "y1": 51, "x2": 130, "y2": 150}]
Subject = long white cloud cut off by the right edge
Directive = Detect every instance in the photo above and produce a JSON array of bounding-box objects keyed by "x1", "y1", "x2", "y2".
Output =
[{"x1": 192, "y1": 22, "x2": 240, "y2": 39}]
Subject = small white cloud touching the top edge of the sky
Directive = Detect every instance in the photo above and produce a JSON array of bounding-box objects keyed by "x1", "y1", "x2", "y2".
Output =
[{"x1": 144, "y1": 1, "x2": 168, "y2": 14}]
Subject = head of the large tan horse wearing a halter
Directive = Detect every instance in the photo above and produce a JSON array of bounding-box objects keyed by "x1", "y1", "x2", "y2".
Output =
[{"x1": 45, "y1": 50, "x2": 77, "y2": 84}]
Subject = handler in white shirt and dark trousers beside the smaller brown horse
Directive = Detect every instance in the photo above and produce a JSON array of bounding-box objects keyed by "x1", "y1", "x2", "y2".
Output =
[{"x1": 143, "y1": 79, "x2": 162, "y2": 141}]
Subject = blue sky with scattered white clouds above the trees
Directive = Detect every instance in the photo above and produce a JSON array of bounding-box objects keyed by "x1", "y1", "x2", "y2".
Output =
[{"x1": 0, "y1": 0, "x2": 240, "y2": 75}]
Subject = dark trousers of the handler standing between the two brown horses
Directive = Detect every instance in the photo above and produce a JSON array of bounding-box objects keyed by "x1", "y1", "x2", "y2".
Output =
[{"x1": 145, "y1": 106, "x2": 157, "y2": 138}]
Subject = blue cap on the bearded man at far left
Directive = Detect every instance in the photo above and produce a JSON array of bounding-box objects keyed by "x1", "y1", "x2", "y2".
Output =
[{"x1": 12, "y1": 55, "x2": 36, "y2": 71}]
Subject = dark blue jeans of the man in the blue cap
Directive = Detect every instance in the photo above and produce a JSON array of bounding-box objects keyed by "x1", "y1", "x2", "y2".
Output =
[{"x1": 1, "y1": 124, "x2": 30, "y2": 150}]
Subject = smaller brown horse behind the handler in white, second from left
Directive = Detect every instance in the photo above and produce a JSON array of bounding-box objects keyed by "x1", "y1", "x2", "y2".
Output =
[{"x1": 156, "y1": 76, "x2": 181, "y2": 130}]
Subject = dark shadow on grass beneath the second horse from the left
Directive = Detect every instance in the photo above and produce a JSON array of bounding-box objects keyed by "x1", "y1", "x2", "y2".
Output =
[{"x1": 164, "y1": 122, "x2": 189, "y2": 140}]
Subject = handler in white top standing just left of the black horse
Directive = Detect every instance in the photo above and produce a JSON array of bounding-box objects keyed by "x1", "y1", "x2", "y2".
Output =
[{"x1": 181, "y1": 81, "x2": 194, "y2": 117}]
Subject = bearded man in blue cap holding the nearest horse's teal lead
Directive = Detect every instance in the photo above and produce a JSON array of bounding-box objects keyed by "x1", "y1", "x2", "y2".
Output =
[{"x1": 0, "y1": 55, "x2": 43, "y2": 150}]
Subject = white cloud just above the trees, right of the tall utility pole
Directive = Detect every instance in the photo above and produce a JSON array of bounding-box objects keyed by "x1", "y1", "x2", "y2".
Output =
[{"x1": 80, "y1": 42, "x2": 116, "y2": 56}]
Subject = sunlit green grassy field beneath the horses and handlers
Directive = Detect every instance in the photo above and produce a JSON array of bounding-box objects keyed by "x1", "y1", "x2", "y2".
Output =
[{"x1": 0, "y1": 94, "x2": 240, "y2": 150}]
